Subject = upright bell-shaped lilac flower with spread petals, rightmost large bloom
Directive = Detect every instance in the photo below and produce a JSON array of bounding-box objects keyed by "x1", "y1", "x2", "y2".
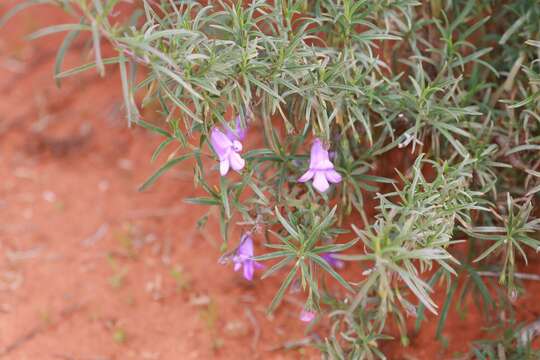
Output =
[{"x1": 298, "y1": 139, "x2": 341, "y2": 193}]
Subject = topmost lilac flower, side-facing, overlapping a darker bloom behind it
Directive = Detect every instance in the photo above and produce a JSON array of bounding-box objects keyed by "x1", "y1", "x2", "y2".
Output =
[{"x1": 210, "y1": 117, "x2": 246, "y2": 176}]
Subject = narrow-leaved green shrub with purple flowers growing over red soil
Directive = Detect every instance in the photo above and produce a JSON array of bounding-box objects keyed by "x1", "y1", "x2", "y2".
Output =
[{"x1": 2, "y1": 0, "x2": 540, "y2": 359}]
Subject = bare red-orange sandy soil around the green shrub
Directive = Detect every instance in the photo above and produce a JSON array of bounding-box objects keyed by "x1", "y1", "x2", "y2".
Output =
[{"x1": 0, "y1": 1, "x2": 540, "y2": 360}]
